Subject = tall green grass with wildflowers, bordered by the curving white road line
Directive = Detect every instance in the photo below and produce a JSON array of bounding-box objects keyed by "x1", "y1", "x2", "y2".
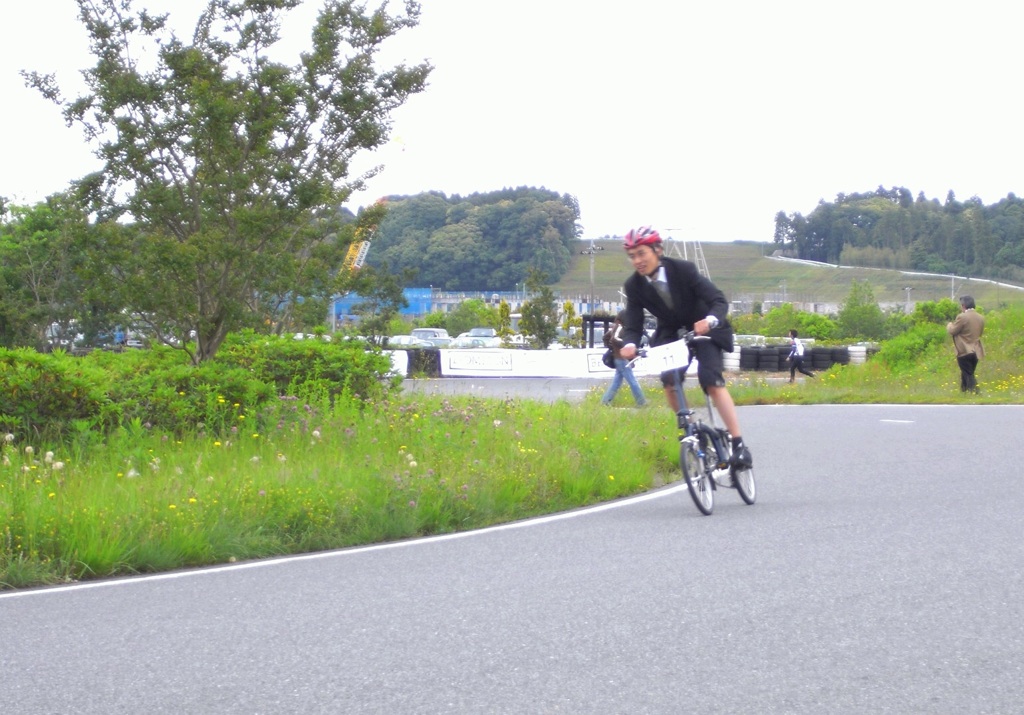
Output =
[{"x1": 0, "y1": 389, "x2": 677, "y2": 587}]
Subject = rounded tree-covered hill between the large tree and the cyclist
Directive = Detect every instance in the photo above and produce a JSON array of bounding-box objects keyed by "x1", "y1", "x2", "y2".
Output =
[{"x1": 367, "y1": 186, "x2": 580, "y2": 291}]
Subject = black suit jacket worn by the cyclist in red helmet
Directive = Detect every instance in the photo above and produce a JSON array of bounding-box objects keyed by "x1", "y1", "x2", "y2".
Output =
[{"x1": 622, "y1": 256, "x2": 732, "y2": 350}]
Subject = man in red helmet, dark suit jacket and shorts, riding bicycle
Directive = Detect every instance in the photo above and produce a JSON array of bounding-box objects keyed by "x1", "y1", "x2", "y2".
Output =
[{"x1": 621, "y1": 226, "x2": 754, "y2": 469}]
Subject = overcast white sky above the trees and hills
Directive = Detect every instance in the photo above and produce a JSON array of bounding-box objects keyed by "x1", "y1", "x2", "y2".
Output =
[{"x1": 0, "y1": 0, "x2": 1024, "y2": 241}]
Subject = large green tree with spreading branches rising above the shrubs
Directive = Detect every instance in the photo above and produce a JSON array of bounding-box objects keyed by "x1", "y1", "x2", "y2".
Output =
[{"x1": 26, "y1": 0, "x2": 431, "y2": 363}]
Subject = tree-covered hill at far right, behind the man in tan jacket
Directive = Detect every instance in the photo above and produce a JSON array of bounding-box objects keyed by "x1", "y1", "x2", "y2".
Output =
[{"x1": 774, "y1": 186, "x2": 1024, "y2": 282}]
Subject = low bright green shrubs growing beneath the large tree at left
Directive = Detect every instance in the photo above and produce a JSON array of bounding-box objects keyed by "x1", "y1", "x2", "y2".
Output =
[{"x1": 0, "y1": 333, "x2": 399, "y2": 439}]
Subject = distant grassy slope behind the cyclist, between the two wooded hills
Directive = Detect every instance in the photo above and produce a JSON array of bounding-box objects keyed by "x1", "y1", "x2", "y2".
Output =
[{"x1": 554, "y1": 241, "x2": 1024, "y2": 308}]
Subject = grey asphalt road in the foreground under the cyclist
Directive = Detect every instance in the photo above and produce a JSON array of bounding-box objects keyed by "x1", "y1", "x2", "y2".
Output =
[{"x1": 0, "y1": 406, "x2": 1024, "y2": 715}]
